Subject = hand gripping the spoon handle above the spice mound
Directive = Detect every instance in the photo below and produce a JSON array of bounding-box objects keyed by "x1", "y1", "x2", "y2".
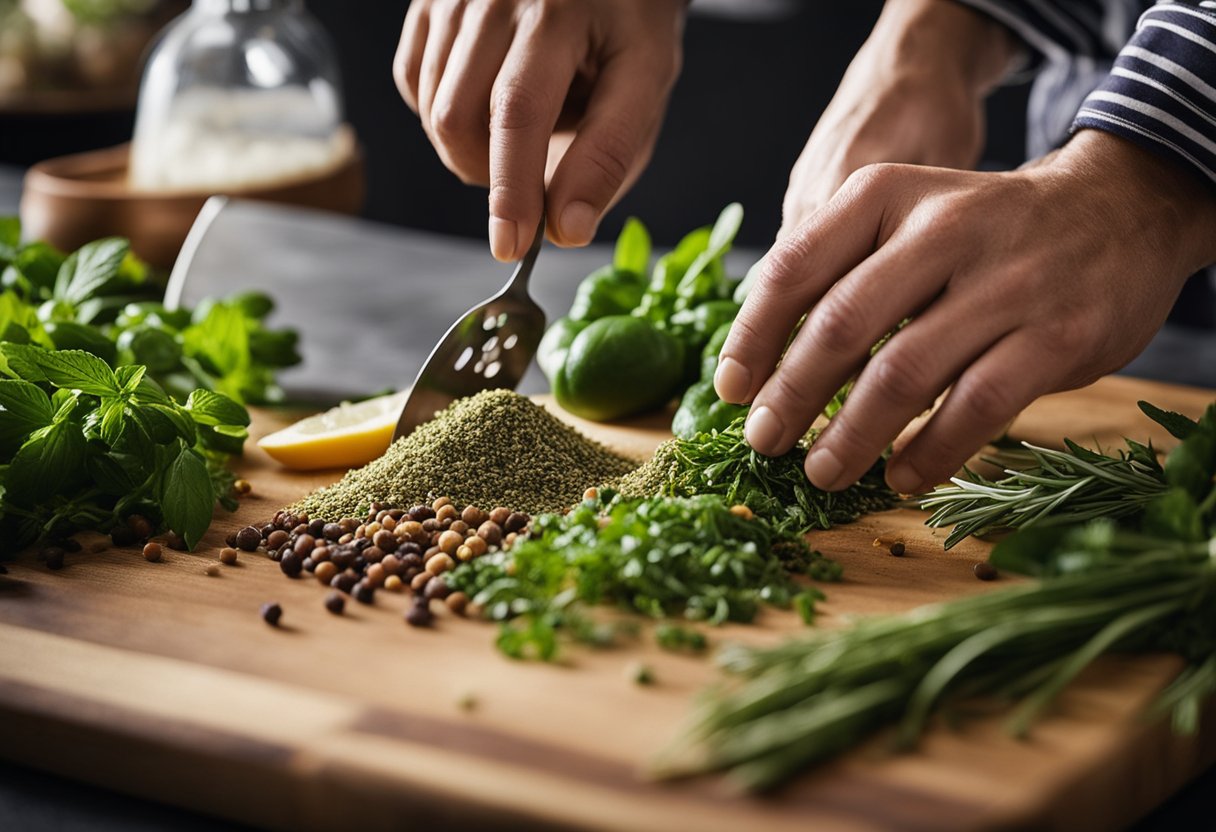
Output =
[{"x1": 393, "y1": 0, "x2": 687, "y2": 260}]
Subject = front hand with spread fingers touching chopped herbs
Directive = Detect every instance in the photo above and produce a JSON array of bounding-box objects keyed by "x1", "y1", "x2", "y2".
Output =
[{"x1": 714, "y1": 130, "x2": 1216, "y2": 493}]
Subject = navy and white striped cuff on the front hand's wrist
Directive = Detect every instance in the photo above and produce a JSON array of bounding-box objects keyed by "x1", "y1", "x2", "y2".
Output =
[{"x1": 1073, "y1": 0, "x2": 1216, "y2": 184}]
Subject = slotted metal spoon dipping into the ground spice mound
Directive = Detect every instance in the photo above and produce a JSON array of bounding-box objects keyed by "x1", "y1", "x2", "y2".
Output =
[{"x1": 393, "y1": 214, "x2": 545, "y2": 440}]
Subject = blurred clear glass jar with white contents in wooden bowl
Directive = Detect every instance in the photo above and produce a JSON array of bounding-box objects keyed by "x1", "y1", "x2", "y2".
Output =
[{"x1": 130, "y1": 0, "x2": 354, "y2": 192}]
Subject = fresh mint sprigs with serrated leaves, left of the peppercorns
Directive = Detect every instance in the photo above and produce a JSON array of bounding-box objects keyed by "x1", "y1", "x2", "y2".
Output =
[{"x1": 0, "y1": 342, "x2": 249, "y2": 551}]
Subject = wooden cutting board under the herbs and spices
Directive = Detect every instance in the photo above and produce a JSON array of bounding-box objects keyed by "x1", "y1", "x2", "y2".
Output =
[{"x1": 0, "y1": 378, "x2": 1216, "y2": 831}]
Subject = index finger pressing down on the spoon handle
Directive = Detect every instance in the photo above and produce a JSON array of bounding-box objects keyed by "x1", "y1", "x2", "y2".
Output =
[{"x1": 490, "y1": 7, "x2": 580, "y2": 260}]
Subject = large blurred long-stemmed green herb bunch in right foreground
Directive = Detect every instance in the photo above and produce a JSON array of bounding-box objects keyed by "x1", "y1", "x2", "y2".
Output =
[{"x1": 657, "y1": 405, "x2": 1216, "y2": 789}]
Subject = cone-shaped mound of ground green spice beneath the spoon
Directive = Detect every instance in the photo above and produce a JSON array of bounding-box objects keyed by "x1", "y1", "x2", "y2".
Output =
[{"x1": 291, "y1": 390, "x2": 637, "y2": 522}]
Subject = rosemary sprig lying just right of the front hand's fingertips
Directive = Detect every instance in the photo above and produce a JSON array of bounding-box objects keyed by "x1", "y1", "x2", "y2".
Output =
[{"x1": 919, "y1": 401, "x2": 1203, "y2": 549}]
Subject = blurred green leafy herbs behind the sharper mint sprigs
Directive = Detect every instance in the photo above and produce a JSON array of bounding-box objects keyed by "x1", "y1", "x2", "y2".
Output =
[{"x1": 0, "y1": 218, "x2": 300, "y2": 403}]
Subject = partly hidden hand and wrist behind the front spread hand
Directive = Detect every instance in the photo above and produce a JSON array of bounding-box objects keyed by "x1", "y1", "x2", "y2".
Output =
[{"x1": 777, "y1": 0, "x2": 1017, "y2": 240}]
